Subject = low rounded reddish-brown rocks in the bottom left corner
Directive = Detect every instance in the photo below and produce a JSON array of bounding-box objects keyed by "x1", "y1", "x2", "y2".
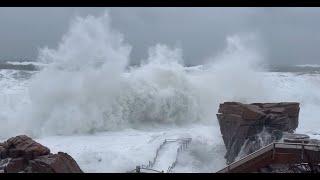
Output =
[{"x1": 0, "y1": 135, "x2": 83, "y2": 173}]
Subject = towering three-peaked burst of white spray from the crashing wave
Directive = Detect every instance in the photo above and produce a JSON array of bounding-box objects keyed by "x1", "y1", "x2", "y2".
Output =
[{"x1": 0, "y1": 9, "x2": 318, "y2": 141}]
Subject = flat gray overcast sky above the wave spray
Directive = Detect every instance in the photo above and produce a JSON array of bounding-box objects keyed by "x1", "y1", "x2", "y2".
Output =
[{"x1": 0, "y1": 7, "x2": 320, "y2": 64}]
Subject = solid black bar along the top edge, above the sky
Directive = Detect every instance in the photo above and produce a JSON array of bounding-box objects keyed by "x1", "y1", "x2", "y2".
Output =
[{"x1": 0, "y1": 0, "x2": 320, "y2": 7}]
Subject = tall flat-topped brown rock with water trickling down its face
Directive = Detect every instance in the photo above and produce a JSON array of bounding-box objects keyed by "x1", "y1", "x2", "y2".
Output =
[{"x1": 217, "y1": 102, "x2": 300, "y2": 164}]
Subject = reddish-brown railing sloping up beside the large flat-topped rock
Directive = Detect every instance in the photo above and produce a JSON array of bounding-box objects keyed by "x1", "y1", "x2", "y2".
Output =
[{"x1": 217, "y1": 142, "x2": 320, "y2": 173}]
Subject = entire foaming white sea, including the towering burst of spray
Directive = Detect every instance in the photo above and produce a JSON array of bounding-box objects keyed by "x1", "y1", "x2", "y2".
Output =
[{"x1": 0, "y1": 13, "x2": 320, "y2": 172}]
